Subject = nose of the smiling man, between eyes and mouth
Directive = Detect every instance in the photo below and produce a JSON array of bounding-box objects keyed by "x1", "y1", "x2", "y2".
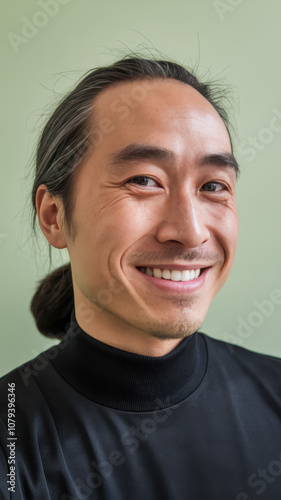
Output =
[{"x1": 157, "y1": 192, "x2": 210, "y2": 248}]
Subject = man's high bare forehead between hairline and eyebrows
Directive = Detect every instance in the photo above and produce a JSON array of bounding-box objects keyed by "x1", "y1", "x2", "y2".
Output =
[{"x1": 91, "y1": 79, "x2": 231, "y2": 154}]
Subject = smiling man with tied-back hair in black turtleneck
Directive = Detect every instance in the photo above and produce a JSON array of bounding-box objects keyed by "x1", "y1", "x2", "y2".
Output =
[{"x1": 1, "y1": 58, "x2": 281, "y2": 500}]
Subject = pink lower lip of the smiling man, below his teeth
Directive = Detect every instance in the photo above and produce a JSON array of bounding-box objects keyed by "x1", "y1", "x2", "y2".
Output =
[{"x1": 137, "y1": 267, "x2": 211, "y2": 293}]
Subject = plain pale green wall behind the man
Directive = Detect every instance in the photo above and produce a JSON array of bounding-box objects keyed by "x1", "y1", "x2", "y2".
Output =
[{"x1": 0, "y1": 0, "x2": 281, "y2": 374}]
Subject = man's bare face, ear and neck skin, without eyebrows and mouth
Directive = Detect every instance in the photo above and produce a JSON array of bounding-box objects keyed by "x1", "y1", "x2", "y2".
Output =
[{"x1": 36, "y1": 80, "x2": 238, "y2": 356}]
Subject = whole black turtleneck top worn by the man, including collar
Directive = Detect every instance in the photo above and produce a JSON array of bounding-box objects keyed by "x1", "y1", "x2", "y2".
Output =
[{"x1": 0, "y1": 310, "x2": 281, "y2": 500}]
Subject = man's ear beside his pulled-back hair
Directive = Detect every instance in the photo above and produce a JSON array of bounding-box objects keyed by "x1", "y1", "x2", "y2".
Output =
[{"x1": 36, "y1": 184, "x2": 67, "y2": 248}]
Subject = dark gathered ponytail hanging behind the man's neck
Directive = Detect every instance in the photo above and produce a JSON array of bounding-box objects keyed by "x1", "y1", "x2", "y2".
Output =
[{"x1": 30, "y1": 264, "x2": 74, "y2": 339}]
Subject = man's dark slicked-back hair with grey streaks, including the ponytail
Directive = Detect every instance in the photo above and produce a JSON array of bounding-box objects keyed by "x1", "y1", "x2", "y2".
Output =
[{"x1": 30, "y1": 55, "x2": 236, "y2": 338}]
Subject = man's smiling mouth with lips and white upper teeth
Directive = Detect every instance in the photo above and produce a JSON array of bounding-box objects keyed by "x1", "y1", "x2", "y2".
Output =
[{"x1": 136, "y1": 266, "x2": 212, "y2": 292}]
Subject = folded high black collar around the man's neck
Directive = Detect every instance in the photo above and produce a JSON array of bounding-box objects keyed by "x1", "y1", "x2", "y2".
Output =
[{"x1": 52, "y1": 309, "x2": 207, "y2": 411}]
